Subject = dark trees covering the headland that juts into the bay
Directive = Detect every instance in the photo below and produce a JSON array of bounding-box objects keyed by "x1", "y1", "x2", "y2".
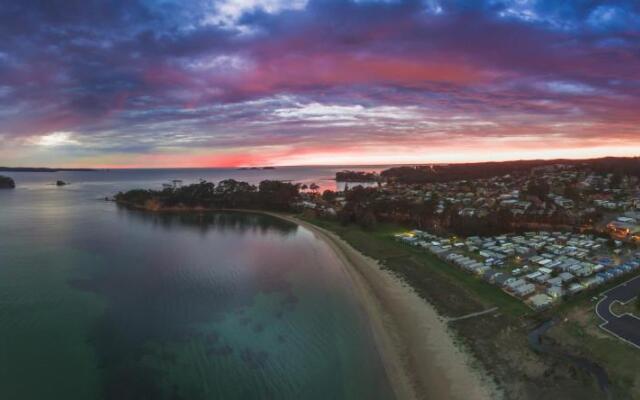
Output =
[{"x1": 115, "y1": 179, "x2": 300, "y2": 211}]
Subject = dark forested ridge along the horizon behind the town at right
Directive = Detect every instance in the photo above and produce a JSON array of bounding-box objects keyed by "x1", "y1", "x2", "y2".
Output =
[{"x1": 380, "y1": 157, "x2": 640, "y2": 184}]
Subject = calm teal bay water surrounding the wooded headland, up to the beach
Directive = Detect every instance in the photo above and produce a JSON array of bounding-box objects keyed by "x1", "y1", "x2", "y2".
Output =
[{"x1": 0, "y1": 169, "x2": 391, "y2": 400}]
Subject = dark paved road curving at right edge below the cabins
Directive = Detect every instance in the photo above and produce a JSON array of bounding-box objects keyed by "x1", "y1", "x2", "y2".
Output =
[{"x1": 596, "y1": 276, "x2": 640, "y2": 349}]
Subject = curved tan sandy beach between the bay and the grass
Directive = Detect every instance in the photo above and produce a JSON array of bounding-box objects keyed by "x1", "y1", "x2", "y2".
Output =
[{"x1": 274, "y1": 214, "x2": 502, "y2": 400}]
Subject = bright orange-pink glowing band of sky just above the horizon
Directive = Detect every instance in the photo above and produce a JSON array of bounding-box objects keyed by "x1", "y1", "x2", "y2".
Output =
[{"x1": 68, "y1": 142, "x2": 640, "y2": 169}]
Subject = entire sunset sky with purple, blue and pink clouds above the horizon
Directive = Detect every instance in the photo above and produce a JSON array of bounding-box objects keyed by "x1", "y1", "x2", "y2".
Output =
[{"x1": 0, "y1": 0, "x2": 640, "y2": 168}]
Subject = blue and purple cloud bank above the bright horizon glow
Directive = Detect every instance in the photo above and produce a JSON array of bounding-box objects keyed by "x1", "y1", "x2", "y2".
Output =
[{"x1": 0, "y1": 0, "x2": 640, "y2": 162}]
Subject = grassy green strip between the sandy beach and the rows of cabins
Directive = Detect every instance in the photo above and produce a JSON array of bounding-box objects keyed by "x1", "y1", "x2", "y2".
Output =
[{"x1": 299, "y1": 215, "x2": 640, "y2": 400}]
